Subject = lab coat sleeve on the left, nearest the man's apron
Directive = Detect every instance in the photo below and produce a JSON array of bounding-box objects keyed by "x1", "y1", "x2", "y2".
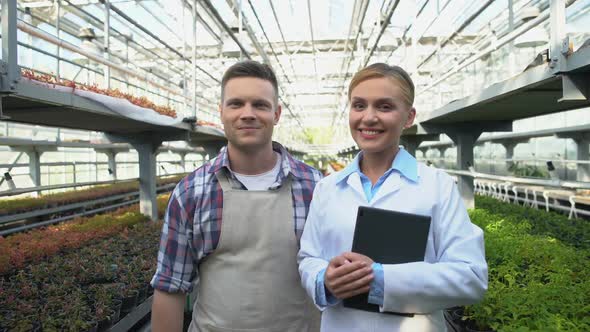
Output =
[{"x1": 297, "y1": 181, "x2": 329, "y2": 310}]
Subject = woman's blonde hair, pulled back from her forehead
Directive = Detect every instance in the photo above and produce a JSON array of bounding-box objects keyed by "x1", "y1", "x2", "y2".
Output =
[{"x1": 348, "y1": 63, "x2": 414, "y2": 106}]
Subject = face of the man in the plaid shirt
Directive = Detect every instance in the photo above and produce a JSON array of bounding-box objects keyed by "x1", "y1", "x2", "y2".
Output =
[{"x1": 219, "y1": 77, "x2": 281, "y2": 150}]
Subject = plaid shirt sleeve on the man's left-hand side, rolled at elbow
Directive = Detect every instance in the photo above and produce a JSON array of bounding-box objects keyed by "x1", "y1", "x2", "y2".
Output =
[{"x1": 151, "y1": 180, "x2": 196, "y2": 293}]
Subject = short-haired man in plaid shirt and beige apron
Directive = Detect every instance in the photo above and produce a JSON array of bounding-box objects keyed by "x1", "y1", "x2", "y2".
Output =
[{"x1": 152, "y1": 61, "x2": 321, "y2": 332}]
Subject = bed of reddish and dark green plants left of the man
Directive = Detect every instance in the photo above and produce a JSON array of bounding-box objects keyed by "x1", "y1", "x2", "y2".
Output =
[{"x1": 0, "y1": 195, "x2": 168, "y2": 331}]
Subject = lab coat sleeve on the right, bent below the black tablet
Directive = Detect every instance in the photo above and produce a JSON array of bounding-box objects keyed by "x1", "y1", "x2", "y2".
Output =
[{"x1": 381, "y1": 174, "x2": 488, "y2": 314}]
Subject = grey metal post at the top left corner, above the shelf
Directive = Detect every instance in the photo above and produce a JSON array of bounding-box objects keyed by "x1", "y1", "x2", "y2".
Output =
[{"x1": 0, "y1": 0, "x2": 20, "y2": 92}]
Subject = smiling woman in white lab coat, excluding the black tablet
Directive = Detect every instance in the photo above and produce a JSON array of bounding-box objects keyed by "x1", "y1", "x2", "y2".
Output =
[{"x1": 298, "y1": 63, "x2": 487, "y2": 332}]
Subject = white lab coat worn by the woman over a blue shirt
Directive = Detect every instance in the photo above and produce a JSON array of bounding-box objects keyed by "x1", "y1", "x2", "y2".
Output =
[{"x1": 298, "y1": 163, "x2": 487, "y2": 332}]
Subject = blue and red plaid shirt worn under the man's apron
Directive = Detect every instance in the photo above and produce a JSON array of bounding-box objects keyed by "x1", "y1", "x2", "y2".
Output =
[{"x1": 151, "y1": 142, "x2": 322, "y2": 293}]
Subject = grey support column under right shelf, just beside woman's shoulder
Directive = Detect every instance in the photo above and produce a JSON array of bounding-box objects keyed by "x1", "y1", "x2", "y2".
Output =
[{"x1": 447, "y1": 131, "x2": 481, "y2": 209}]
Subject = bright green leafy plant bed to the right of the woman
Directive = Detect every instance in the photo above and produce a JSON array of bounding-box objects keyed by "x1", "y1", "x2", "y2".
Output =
[{"x1": 446, "y1": 196, "x2": 590, "y2": 331}]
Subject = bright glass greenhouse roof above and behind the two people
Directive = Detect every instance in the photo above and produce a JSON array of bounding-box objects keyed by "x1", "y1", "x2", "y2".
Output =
[{"x1": 11, "y1": 0, "x2": 590, "y2": 149}]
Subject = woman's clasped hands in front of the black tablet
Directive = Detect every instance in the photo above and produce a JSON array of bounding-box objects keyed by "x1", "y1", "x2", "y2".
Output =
[{"x1": 324, "y1": 253, "x2": 373, "y2": 299}]
